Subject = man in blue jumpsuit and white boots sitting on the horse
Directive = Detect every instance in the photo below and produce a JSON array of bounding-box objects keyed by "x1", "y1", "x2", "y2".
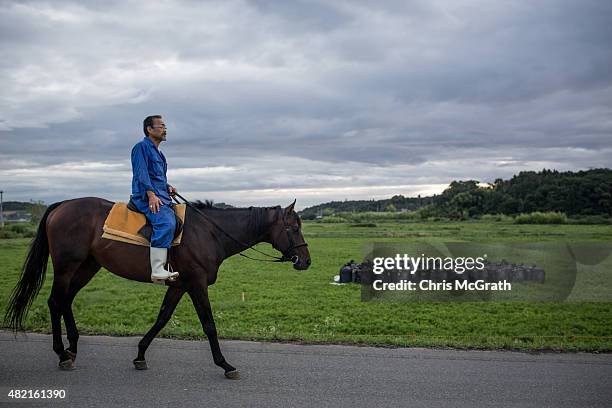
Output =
[{"x1": 130, "y1": 115, "x2": 179, "y2": 284}]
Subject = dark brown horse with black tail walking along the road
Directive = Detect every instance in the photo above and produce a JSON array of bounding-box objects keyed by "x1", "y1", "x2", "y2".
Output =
[{"x1": 5, "y1": 197, "x2": 310, "y2": 379}]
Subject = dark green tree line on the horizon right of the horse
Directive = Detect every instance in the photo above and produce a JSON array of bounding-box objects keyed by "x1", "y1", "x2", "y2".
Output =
[{"x1": 300, "y1": 169, "x2": 612, "y2": 219}]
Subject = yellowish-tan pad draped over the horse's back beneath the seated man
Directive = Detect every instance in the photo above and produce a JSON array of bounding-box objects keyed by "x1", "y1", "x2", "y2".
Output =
[{"x1": 102, "y1": 202, "x2": 187, "y2": 246}]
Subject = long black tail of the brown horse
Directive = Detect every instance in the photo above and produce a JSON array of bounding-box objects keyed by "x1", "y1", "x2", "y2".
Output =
[{"x1": 4, "y1": 201, "x2": 63, "y2": 331}]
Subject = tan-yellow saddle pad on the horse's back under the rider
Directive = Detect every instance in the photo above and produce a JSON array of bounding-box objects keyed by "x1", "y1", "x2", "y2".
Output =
[{"x1": 102, "y1": 201, "x2": 186, "y2": 246}]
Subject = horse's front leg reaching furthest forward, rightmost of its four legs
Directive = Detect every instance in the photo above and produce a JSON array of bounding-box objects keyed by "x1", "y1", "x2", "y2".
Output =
[{"x1": 189, "y1": 286, "x2": 240, "y2": 380}]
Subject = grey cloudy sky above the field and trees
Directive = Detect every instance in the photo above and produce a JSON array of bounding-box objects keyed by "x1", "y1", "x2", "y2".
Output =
[{"x1": 0, "y1": 0, "x2": 612, "y2": 208}]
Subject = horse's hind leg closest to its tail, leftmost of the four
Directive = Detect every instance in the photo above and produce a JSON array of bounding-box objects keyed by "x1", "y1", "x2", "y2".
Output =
[{"x1": 47, "y1": 262, "x2": 81, "y2": 370}]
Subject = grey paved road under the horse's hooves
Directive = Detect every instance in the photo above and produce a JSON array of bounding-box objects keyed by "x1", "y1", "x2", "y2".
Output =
[{"x1": 0, "y1": 331, "x2": 612, "y2": 408}]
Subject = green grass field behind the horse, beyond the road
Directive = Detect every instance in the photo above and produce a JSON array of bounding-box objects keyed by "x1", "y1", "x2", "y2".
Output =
[{"x1": 0, "y1": 221, "x2": 612, "y2": 352}]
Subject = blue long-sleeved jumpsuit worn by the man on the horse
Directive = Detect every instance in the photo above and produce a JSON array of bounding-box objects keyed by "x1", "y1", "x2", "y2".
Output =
[{"x1": 131, "y1": 136, "x2": 176, "y2": 248}]
